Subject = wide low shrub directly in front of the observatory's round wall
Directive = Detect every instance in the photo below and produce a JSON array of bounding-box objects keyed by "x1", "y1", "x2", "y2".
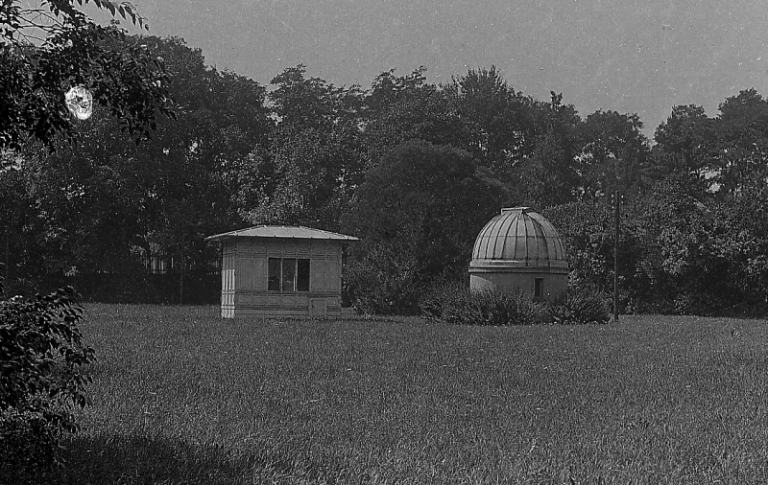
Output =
[{"x1": 419, "y1": 284, "x2": 546, "y2": 325}]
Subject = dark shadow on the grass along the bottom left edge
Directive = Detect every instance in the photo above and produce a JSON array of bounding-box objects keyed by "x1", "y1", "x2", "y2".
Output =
[{"x1": 6, "y1": 436, "x2": 360, "y2": 485}]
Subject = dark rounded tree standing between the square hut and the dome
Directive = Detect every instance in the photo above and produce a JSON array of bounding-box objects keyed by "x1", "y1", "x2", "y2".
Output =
[{"x1": 342, "y1": 140, "x2": 500, "y2": 313}]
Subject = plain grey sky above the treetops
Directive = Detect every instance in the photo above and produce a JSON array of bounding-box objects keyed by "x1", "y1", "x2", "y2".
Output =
[{"x1": 118, "y1": 0, "x2": 768, "y2": 136}]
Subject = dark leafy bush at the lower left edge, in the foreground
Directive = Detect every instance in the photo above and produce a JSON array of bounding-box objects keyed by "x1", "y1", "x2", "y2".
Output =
[{"x1": 0, "y1": 288, "x2": 94, "y2": 476}]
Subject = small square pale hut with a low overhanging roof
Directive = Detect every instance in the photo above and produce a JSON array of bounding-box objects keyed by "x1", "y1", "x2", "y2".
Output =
[{"x1": 206, "y1": 226, "x2": 357, "y2": 318}]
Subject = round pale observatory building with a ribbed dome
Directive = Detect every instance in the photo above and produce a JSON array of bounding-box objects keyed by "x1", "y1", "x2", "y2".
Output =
[{"x1": 469, "y1": 207, "x2": 568, "y2": 300}]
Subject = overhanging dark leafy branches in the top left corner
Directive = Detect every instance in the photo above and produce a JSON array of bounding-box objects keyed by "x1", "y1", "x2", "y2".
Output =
[{"x1": 0, "y1": 0, "x2": 171, "y2": 149}]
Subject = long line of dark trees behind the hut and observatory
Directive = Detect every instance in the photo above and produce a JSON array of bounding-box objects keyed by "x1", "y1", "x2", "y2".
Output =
[{"x1": 0, "y1": 35, "x2": 768, "y2": 313}]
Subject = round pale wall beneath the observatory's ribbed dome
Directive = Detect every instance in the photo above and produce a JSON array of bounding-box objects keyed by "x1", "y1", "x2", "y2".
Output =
[{"x1": 469, "y1": 269, "x2": 568, "y2": 301}]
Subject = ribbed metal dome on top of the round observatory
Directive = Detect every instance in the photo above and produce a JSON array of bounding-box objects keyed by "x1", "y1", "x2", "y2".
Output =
[{"x1": 470, "y1": 207, "x2": 568, "y2": 271}]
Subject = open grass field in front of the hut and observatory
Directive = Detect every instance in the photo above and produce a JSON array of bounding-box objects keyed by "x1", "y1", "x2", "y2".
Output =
[{"x1": 48, "y1": 305, "x2": 768, "y2": 484}]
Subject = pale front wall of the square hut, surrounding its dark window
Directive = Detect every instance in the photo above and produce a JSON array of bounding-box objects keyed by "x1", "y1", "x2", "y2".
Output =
[{"x1": 228, "y1": 238, "x2": 341, "y2": 317}]
